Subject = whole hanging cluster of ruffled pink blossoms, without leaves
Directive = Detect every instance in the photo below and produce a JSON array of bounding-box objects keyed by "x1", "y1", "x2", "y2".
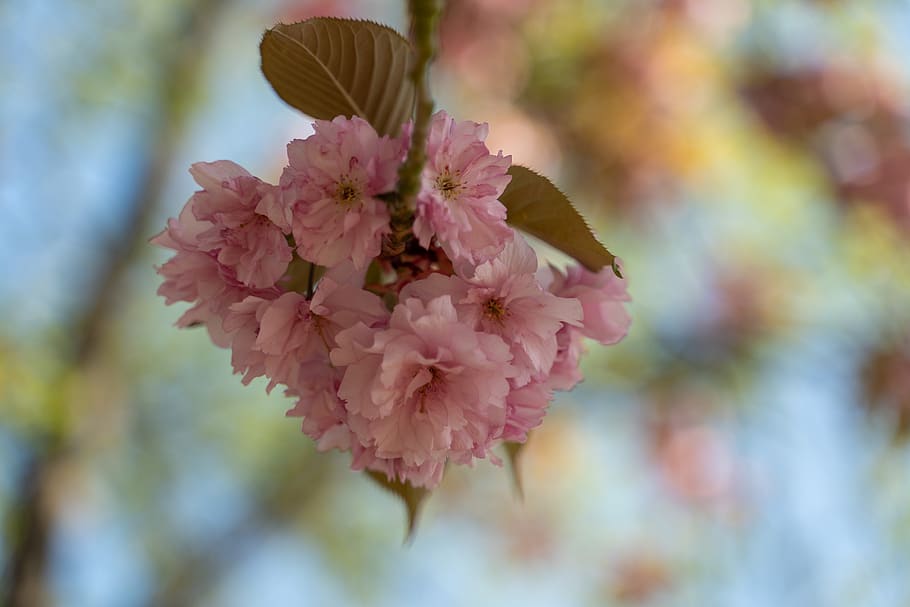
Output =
[{"x1": 152, "y1": 112, "x2": 630, "y2": 487}]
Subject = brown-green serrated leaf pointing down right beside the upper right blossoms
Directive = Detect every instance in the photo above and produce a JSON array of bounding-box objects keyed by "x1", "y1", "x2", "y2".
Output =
[{"x1": 499, "y1": 165, "x2": 622, "y2": 278}]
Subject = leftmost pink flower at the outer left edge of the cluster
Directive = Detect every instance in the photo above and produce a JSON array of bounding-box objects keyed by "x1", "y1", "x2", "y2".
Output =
[{"x1": 150, "y1": 192, "x2": 279, "y2": 348}]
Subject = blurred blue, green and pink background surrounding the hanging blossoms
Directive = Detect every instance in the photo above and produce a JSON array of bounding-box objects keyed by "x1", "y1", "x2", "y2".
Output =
[{"x1": 0, "y1": 0, "x2": 910, "y2": 607}]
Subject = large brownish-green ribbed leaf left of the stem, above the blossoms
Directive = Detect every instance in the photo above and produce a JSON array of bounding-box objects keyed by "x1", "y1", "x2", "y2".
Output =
[{"x1": 259, "y1": 17, "x2": 414, "y2": 136}]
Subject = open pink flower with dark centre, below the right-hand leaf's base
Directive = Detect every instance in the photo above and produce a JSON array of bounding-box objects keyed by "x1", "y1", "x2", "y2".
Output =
[{"x1": 401, "y1": 235, "x2": 581, "y2": 386}]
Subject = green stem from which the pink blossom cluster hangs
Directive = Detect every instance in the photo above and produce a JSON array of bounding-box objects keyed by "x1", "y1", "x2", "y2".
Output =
[{"x1": 384, "y1": 0, "x2": 439, "y2": 255}]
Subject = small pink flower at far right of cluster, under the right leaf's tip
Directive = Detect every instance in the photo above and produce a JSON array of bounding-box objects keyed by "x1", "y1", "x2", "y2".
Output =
[{"x1": 544, "y1": 265, "x2": 632, "y2": 345}]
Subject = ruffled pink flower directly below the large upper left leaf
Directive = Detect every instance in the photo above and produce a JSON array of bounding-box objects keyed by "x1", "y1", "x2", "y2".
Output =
[{"x1": 281, "y1": 116, "x2": 405, "y2": 268}]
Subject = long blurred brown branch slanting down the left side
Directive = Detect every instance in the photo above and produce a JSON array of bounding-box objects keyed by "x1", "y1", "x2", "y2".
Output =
[{"x1": 0, "y1": 0, "x2": 228, "y2": 606}]
